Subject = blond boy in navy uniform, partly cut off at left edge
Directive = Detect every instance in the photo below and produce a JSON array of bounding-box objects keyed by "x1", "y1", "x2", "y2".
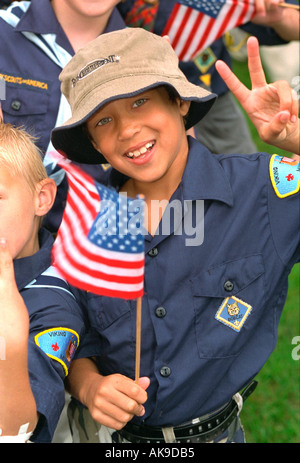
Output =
[{"x1": 0, "y1": 123, "x2": 84, "y2": 442}]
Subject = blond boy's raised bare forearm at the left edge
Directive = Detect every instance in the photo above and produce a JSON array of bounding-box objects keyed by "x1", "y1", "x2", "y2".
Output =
[{"x1": 0, "y1": 239, "x2": 38, "y2": 442}]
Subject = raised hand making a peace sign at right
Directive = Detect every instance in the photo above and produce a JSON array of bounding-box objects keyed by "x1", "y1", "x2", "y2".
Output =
[{"x1": 216, "y1": 37, "x2": 300, "y2": 154}]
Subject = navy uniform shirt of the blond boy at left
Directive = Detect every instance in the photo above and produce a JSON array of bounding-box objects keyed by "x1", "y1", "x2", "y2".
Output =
[{"x1": 14, "y1": 229, "x2": 85, "y2": 442}]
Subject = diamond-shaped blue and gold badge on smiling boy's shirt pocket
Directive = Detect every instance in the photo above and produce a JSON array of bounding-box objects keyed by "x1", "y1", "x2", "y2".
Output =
[{"x1": 215, "y1": 296, "x2": 252, "y2": 331}]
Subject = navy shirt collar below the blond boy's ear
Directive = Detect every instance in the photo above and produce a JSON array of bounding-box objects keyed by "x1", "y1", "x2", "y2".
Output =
[{"x1": 14, "y1": 228, "x2": 53, "y2": 291}]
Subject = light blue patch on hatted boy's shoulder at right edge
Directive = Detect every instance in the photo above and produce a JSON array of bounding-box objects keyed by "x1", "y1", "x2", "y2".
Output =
[{"x1": 270, "y1": 154, "x2": 300, "y2": 198}]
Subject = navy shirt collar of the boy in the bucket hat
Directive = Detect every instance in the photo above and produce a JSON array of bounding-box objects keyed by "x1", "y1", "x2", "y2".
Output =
[{"x1": 108, "y1": 137, "x2": 233, "y2": 206}]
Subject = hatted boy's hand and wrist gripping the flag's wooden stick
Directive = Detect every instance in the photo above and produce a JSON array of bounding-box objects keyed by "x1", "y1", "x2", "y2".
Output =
[{"x1": 67, "y1": 359, "x2": 150, "y2": 429}]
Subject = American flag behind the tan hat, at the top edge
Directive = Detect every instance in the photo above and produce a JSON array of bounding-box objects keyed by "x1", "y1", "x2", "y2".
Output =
[{"x1": 162, "y1": 0, "x2": 255, "y2": 61}]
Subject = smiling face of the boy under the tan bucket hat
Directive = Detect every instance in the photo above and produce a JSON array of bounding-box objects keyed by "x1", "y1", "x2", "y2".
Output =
[{"x1": 87, "y1": 87, "x2": 189, "y2": 194}]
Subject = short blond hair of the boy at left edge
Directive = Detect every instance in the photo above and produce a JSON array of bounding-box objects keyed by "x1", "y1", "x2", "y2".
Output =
[{"x1": 0, "y1": 122, "x2": 48, "y2": 191}]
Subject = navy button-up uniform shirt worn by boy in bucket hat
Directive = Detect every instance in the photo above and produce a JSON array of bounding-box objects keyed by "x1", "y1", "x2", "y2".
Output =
[{"x1": 78, "y1": 138, "x2": 300, "y2": 426}]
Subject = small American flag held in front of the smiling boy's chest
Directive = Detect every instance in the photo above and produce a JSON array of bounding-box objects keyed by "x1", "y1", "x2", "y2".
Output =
[{"x1": 52, "y1": 156, "x2": 144, "y2": 299}]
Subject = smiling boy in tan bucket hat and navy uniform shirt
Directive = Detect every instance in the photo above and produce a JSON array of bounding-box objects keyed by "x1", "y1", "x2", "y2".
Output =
[{"x1": 52, "y1": 29, "x2": 299, "y2": 442}]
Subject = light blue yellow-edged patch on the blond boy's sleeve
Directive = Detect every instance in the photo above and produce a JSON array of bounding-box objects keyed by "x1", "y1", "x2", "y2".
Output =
[{"x1": 34, "y1": 328, "x2": 79, "y2": 375}]
